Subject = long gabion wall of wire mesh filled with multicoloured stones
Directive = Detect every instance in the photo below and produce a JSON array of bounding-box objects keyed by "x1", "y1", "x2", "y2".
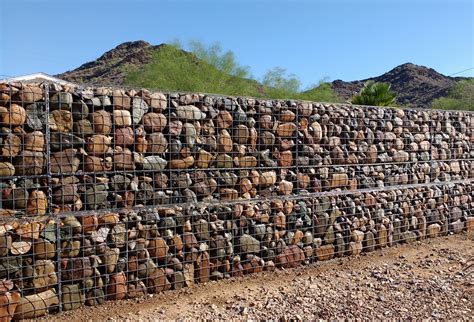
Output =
[{"x1": 0, "y1": 83, "x2": 474, "y2": 321}]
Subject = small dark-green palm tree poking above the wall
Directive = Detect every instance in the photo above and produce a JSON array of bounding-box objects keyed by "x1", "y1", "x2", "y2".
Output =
[{"x1": 352, "y1": 81, "x2": 397, "y2": 106}]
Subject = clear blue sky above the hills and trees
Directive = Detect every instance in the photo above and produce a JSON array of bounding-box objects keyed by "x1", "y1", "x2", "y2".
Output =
[{"x1": 0, "y1": 0, "x2": 474, "y2": 86}]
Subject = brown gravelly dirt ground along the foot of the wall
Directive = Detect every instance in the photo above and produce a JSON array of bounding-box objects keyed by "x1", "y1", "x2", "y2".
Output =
[{"x1": 50, "y1": 233, "x2": 474, "y2": 320}]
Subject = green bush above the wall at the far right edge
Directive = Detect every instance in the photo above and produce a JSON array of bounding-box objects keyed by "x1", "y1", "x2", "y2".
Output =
[{"x1": 431, "y1": 78, "x2": 474, "y2": 111}]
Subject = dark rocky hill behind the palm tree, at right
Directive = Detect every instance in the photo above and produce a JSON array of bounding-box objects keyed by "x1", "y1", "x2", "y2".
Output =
[{"x1": 332, "y1": 63, "x2": 463, "y2": 107}]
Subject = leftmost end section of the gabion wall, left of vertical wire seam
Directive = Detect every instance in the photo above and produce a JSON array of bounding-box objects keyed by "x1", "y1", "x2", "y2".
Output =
[{"x1": 0, "y1": 83, "x2": 59, "y2": 321}]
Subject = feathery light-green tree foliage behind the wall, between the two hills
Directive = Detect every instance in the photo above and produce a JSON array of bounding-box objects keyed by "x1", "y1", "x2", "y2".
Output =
[{"x1": 125, "y1": 40, "x2": 340, "y2": 102}]
